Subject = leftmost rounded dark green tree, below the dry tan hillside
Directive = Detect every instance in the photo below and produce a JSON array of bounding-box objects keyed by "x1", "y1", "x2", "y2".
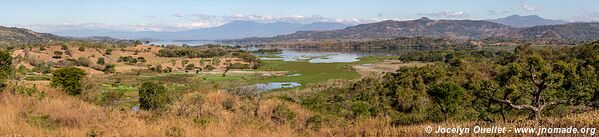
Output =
[{"x1": 50, "y1": 67, "x2": 85, "y2": 95}]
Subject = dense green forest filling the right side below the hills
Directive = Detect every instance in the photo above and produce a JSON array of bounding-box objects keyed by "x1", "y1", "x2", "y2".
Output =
[{"x1": 294, "y1": 42, "x2": 599, "y2": 125}]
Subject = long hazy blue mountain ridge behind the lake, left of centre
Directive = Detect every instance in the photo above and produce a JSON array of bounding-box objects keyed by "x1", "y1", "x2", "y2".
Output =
[{"x1": 54, "y1": 21, "x2": 349, "y2": 40}]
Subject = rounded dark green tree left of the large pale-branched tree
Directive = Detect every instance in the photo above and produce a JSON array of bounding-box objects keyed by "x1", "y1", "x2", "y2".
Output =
[{"x1": 428, "y1": 82, "x2": 465, "y2": 122}]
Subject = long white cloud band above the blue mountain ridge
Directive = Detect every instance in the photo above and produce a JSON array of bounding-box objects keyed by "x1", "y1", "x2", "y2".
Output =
[{"x1": 19, "y1": 14, "x2": 386, "y2": 32}]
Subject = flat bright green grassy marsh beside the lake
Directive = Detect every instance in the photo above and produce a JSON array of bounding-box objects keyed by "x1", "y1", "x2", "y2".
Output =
[{"x1": 91, "y1": 56, "x2": 396, "y2": 97}]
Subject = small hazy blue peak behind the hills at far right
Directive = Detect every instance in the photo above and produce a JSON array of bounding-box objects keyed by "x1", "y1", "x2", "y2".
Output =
[{"x1": 487, "y1": 15, "x2": 570, "y2": 28}]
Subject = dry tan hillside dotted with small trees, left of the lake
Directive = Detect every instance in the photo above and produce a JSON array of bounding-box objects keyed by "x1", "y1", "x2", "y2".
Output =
[{"x1": 12, "y1": 45, "x2": 255, "y2": 75}]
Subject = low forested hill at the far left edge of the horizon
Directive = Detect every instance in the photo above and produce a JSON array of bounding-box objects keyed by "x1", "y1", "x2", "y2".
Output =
[{"x1": 0, "y1": 26, "x2": 69, "y2": 45}]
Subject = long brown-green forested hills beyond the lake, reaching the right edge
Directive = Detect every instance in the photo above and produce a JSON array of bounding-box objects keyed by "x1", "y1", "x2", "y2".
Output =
[{"x1": 231, "y1": 18, "x2": 599, "y2": 43}]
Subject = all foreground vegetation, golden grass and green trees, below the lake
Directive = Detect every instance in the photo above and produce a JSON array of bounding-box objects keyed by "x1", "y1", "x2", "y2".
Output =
[{"x1": 0, "y1": 42, "x2": 599, "y2": 136}]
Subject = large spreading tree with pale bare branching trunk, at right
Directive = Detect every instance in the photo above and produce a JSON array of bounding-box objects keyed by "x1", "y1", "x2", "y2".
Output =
[{"x1": 494, "y1": 54, "x2": 564, "y2": 120}]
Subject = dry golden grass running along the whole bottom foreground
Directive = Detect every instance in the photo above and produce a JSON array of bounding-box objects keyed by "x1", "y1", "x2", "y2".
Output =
[{"x1": 0, "y1": 81, "x2": 599, "y2": 137}]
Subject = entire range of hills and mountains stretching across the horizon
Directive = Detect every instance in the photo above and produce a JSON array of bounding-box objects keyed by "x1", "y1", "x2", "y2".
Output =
[{"x1": 0, "y1": 14, "x2": 599, "y2": 45}]
